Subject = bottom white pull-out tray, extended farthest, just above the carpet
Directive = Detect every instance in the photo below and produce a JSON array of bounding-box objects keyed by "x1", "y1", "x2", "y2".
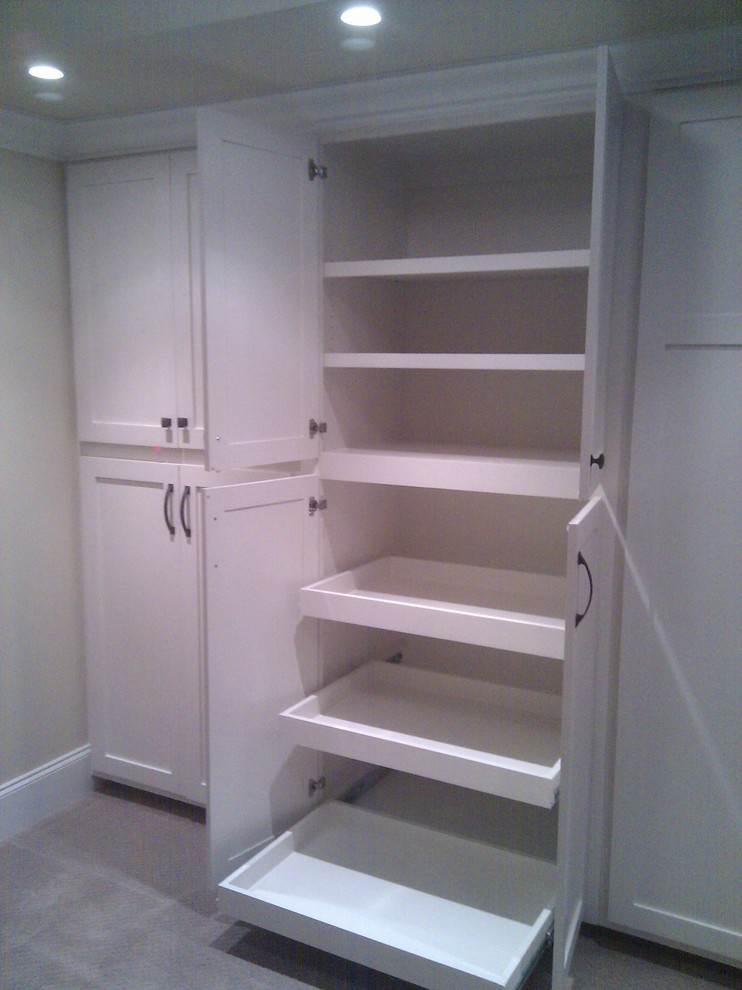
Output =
[{"x1": 219, "y1": 802, "x2": 555, "y2": 990}]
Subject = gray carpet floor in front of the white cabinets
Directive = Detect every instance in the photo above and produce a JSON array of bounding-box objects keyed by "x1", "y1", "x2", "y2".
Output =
[{"x1": 0, "y1": 785, "x2": 742, "y2": 990}]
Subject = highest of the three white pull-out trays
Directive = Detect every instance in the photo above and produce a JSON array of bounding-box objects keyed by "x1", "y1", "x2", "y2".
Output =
[{"x1": 300, "y1": 557, "x2": 565, "y2": 660}]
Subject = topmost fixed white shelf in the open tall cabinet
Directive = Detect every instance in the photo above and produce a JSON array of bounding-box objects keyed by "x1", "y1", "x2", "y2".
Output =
[{"x1": 324, "y1": 250, "x2": 590, "y2": 278}]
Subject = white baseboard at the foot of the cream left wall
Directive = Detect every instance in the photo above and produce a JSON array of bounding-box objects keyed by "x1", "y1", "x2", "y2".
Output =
[{"x1": 0, "y1": 745, "x2": 93, "y2": 842}]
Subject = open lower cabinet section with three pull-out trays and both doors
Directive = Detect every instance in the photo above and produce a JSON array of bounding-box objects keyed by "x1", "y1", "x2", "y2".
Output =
[{"x1": 204, "y1": 475, "x2": 603, "y2": 990}]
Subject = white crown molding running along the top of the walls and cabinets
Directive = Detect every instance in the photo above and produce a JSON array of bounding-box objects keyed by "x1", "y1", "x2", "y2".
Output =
[{"x1": 0, "y1": 24, "x2": 742, "y2": 161}]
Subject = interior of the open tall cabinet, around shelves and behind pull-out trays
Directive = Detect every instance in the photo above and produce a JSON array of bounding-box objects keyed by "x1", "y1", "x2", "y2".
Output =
[{"x1": 310, "y1": 114, "x2": 594, "y2": 836}]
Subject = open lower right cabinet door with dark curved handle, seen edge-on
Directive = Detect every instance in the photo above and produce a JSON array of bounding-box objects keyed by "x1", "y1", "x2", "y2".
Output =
[{"x1": 553, "y1": 498, "x2": 605, "y2": 990}]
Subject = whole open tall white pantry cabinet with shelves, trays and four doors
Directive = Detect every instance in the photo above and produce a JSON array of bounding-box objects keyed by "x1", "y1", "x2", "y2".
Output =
[{"x1": 198, "y1": 52, "x2": 640, "y2": 990}]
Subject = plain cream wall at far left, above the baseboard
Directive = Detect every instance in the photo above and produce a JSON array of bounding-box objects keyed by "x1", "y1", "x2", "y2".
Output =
[{"x1": 0, "y1": 150, "x2": 87, "y2": 808}]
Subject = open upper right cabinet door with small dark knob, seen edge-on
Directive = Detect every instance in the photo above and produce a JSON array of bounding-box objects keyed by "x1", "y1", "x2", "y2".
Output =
[{"x1": 580, "y1": 48, "x2": 623, "y2": 498}]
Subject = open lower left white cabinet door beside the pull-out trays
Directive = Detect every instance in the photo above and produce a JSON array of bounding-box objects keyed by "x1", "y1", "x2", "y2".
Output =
[{"x1": 202, "y1": 475, "x2": 320, "y2": 885}]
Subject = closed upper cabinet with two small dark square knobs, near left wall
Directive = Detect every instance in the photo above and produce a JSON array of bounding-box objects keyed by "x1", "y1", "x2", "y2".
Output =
[{"x1": 67, "y1": 151, "x2": 203, "y2": 449}]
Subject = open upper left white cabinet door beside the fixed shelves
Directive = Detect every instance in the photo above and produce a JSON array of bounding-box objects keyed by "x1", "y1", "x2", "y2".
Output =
[{"x1": 197, "y1": 110, "x2": 322, "y2": 470}]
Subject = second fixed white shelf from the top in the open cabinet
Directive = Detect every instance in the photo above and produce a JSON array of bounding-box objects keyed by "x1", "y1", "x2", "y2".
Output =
[{"x1": 325, "y1": 352, "x2": 585, "y2": 371}]
